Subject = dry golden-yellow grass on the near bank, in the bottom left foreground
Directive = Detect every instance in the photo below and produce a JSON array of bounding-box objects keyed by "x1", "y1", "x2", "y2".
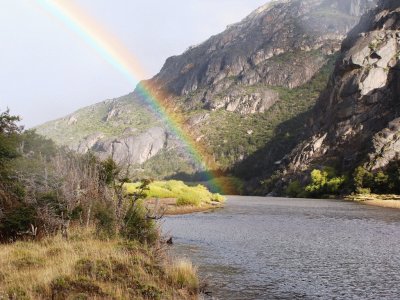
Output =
[{"x1": 0, "y1": 230, "x2": 199, "y2": 299}]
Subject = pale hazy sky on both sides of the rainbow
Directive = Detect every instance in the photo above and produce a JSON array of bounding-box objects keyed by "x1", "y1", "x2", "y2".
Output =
[{"x1": 0, "y1": 0, "x2": 268, "y2": 127}]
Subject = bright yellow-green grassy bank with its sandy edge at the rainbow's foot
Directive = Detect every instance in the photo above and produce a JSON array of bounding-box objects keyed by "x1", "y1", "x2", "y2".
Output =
[{"x1": 125, "y1": 180, "x2": 225, "y2": 214}]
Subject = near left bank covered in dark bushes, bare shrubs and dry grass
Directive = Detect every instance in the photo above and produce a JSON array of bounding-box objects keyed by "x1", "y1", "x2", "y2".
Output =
[{"x1": 0, "y1": 111, "x2": 199, "y2": 299}]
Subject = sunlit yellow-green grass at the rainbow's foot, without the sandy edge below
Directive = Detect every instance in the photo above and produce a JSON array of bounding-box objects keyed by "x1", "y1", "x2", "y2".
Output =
[{"x1": 125, "y1": 180, "x2": 225, "y2": 211}]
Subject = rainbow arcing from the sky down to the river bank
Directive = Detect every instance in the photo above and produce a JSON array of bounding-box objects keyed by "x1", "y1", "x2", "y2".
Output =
[{"x1": 36, "y1": 0, "x2": 232, "y2": 193}]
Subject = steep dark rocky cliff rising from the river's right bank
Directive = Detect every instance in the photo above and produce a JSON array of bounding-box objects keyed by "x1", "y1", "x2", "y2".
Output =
[{"x1": 274, "y1": 0, "x2": 400, "y2": 192}]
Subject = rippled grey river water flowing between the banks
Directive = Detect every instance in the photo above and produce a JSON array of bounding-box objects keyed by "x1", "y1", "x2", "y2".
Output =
[{"x1": 163, "y1": 196, "x2": 400, "y2": 300}]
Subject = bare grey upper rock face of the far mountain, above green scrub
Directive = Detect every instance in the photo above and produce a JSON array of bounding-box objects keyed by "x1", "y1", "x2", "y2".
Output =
[{"x1": 151, "y1": 0, "x2": 376, "y2": 114}]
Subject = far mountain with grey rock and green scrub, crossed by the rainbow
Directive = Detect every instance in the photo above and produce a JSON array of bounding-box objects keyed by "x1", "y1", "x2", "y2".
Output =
[{"x1": 36, "y1": 0, "x2": 376, "y2": 183}]
